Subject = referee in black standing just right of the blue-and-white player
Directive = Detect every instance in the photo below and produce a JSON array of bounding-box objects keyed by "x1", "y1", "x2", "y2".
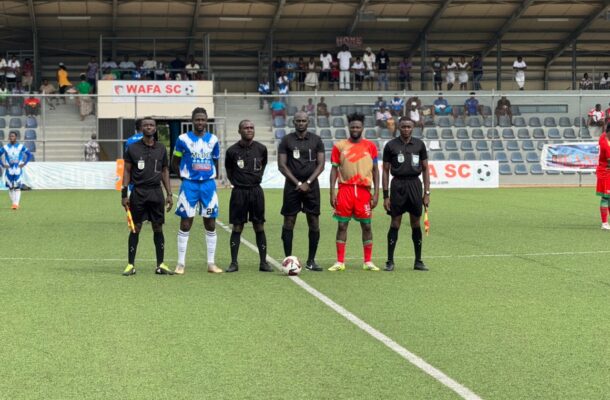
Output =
[{"x1": 225, "y1": 120, "x2": 273, "y2": 272}]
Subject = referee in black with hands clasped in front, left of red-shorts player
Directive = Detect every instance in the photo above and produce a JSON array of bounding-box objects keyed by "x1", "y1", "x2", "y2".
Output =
[{"x1": 277, "y1": 111, "x2": 324, "y2": 271}]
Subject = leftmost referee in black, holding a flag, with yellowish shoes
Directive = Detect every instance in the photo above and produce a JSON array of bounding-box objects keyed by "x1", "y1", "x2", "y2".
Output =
[{"x1": 121, "y1": 117, "x2": 174, "y2": 276}]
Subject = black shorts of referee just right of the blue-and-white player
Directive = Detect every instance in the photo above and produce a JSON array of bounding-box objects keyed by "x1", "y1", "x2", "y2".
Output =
[{"x1": 229, "y1": 186, "x2": 265, "y2": 225}]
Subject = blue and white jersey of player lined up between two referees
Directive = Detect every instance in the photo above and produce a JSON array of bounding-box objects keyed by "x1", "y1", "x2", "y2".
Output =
[{"x1": 174, "y1": 132, "x2": 220, "y2": 181}]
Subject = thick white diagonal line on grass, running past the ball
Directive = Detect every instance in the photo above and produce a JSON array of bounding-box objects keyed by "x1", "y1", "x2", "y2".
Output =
[{"x1": 216, "y1": 220, "x2": 481, "y2": 400}]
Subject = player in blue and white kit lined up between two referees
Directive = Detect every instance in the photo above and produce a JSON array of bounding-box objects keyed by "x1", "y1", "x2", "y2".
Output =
[{"x1": 172, "y1": 107, "x2": 222, "y2": 275}]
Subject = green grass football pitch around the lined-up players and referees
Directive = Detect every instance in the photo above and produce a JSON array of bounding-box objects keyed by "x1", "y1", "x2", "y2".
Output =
[{"x1": 0, "y1": 188, "x2": 610, "y2": 400}]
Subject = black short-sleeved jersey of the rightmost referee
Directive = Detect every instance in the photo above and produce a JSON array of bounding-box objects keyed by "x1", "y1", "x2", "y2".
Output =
[{"x1": 383, "y1": 137, "x2": 428, "y2": 178}]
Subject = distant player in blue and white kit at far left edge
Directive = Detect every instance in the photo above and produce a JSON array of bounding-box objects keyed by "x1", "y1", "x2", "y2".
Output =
[{"x1": 0, "y1": 132, "x2": 32, "y2": 210}]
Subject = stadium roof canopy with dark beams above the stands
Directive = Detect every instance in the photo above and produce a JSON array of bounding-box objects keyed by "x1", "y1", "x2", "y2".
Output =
[{"x1": 0, "y1": 0, "x2": 610, "y2": 61}]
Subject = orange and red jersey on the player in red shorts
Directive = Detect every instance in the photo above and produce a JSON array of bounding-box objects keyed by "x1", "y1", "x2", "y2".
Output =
[{"x1": 330, "y1": 139, "x2": 377, "y2": 187}]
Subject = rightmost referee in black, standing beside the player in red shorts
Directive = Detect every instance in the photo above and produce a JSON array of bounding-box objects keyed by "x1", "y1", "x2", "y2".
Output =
[{"x1": 382, "y1": 117, "x2": 430, "y2": 271}]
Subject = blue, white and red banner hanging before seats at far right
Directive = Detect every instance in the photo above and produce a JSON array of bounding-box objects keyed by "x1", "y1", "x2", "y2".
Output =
[{"x1": 540, "y1": 142, "x2": 599, "y2": 172}]
